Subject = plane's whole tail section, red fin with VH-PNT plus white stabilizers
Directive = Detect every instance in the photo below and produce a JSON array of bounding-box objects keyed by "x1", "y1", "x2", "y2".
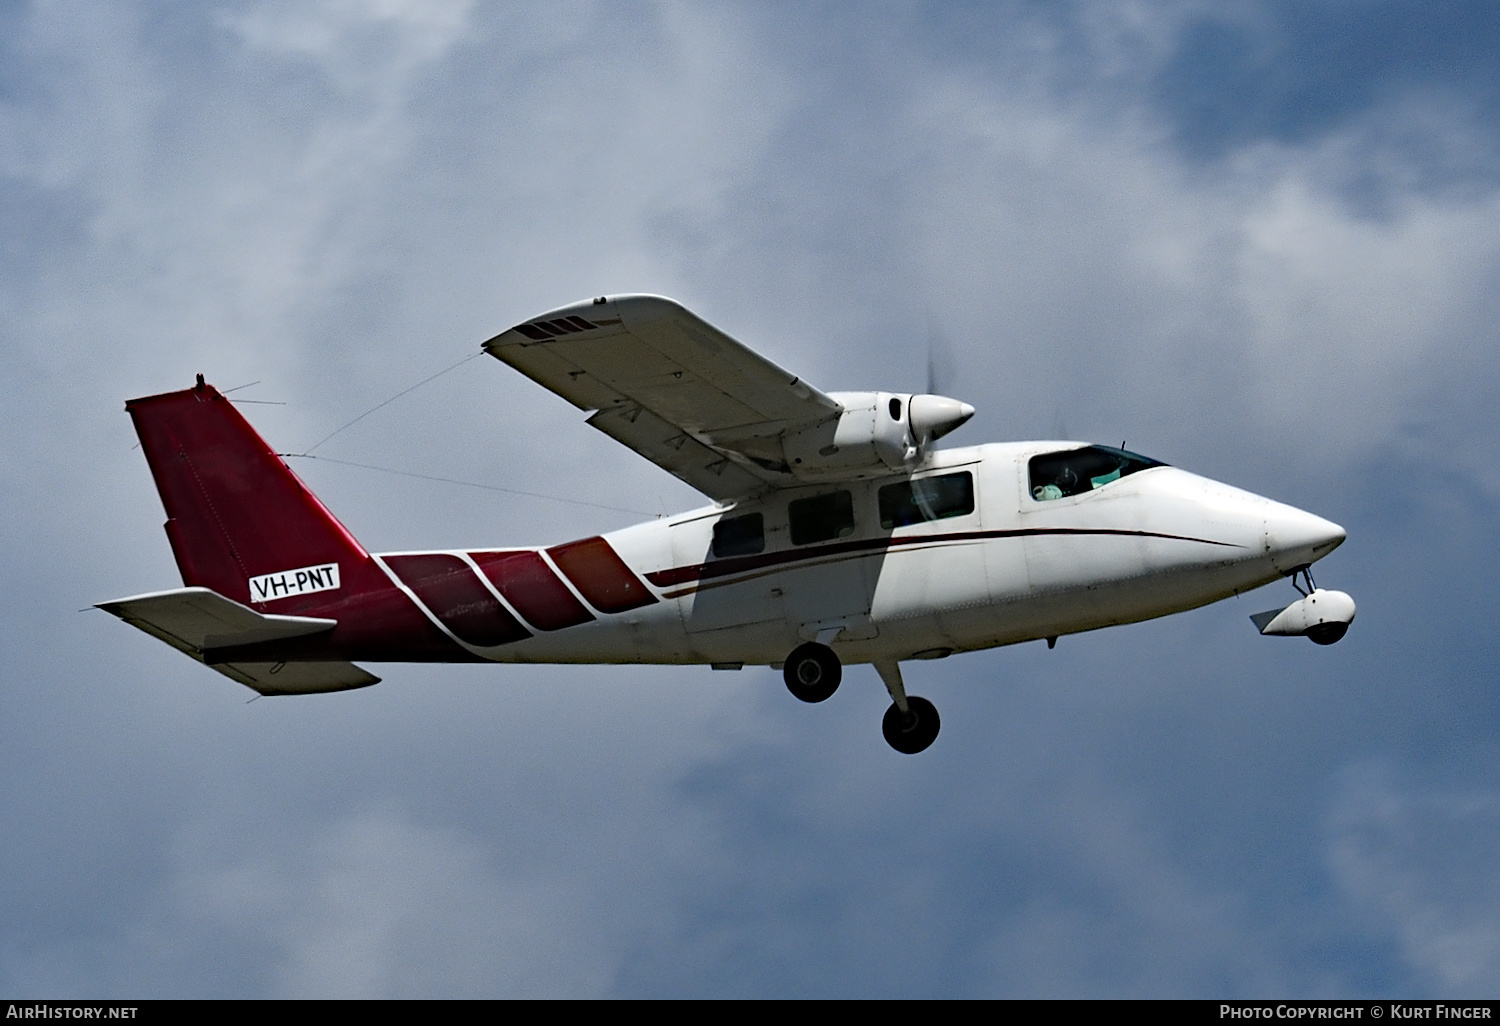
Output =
[{"x1": 117, "y1": 375, "x2": 479, "y2": 666}]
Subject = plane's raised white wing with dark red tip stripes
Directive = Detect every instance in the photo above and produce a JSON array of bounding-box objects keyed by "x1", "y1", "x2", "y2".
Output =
[{"x1": 485, "y1": 296, "x2": 843, "y2": 501}]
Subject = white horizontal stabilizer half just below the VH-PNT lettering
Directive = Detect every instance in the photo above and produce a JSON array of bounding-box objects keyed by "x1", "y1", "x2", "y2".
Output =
[{"x1": 98, "y1": 588, "x2": 339, "y2": 657}]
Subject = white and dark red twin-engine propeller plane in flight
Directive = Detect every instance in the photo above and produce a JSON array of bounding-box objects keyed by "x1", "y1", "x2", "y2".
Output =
[{"x1": 99, "y1": 294, "x2": 1355, "y2": 755}]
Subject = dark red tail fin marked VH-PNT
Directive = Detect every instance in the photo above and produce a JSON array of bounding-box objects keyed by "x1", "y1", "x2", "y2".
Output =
[{"x1": 125, "y1": 375, "x2": 375, "y2": 605}]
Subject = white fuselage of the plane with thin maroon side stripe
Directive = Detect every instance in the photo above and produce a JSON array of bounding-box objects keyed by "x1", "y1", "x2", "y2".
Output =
[{"x1": 366, "y1": 443, "x2": 1344, "y2": 666}]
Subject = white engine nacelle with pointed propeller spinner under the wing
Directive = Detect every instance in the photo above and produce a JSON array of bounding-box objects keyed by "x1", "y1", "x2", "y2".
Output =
[{"x1": 782, "y1": 392, "x2": 974, "y2": 482}]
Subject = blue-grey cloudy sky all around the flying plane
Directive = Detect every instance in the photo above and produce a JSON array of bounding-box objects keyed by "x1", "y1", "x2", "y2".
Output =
[{"x1": 0, "y1": 0, "x2": 1500, "y2": 998}]
